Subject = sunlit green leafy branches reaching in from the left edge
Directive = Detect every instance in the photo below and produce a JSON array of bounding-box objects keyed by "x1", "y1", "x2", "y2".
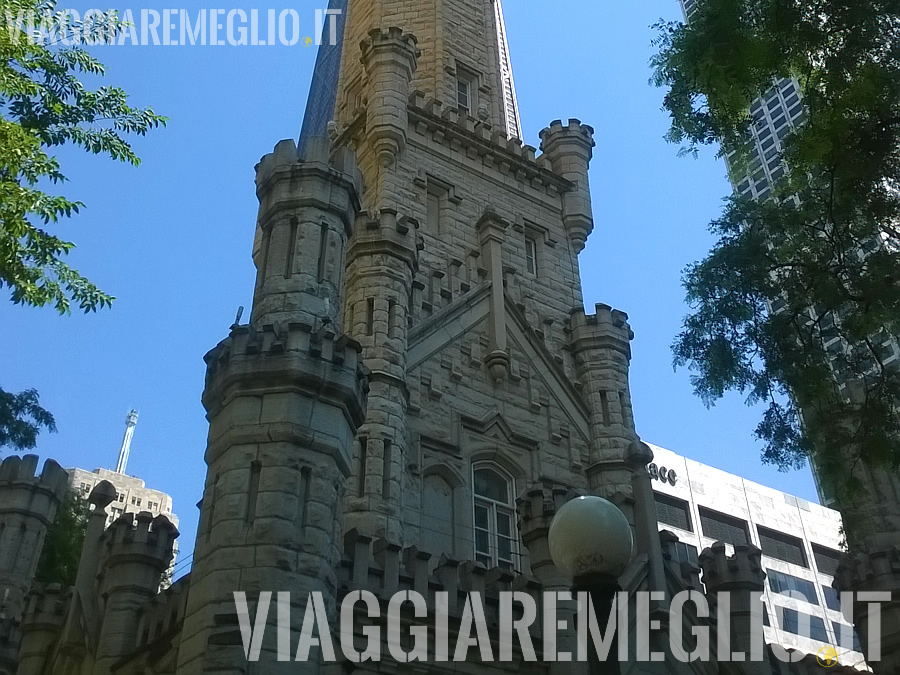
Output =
[{"x1": 0, "y1": 0, "x2": 166, "y2": 449}]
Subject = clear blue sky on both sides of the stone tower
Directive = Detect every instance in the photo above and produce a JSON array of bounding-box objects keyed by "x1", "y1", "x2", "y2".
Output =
[{"x1": 0, "y1": 0, "x2": 816, "y2": 572}]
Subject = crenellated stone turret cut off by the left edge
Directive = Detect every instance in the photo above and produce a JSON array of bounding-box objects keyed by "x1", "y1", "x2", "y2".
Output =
[{"x1": 0, "y1": 455, "x2": 68, "y2": 619}]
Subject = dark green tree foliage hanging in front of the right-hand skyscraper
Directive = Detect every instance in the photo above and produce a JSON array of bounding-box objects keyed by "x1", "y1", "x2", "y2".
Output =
[{"x1": 652, "y1": 0, "x2": 900, "y2": 493}]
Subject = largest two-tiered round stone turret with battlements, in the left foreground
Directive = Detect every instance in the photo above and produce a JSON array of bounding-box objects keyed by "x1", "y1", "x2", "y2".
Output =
[{"x1": 178, "y1": 139, "x2": 367, "y2": 674}]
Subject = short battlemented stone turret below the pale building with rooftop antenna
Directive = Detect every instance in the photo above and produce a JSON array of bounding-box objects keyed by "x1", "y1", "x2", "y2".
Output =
[{"x1": 93, "y1": 511, "x2": 178, "y2": 675}]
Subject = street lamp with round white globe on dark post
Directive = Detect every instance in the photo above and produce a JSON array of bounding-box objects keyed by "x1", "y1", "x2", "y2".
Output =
[{"x1": 548, "y1": 497, "x2": 634, "y2": 675}]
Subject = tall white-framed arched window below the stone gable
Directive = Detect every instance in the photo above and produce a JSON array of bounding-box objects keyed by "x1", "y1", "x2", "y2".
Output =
[{"x1": 472, "y1": 464, "x2": 519, "y2": 570}]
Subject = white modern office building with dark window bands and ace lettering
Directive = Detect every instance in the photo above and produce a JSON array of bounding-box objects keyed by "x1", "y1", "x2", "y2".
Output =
[{"x1": 650, "y1": 445, "x2": 865, "y2": 670}]
